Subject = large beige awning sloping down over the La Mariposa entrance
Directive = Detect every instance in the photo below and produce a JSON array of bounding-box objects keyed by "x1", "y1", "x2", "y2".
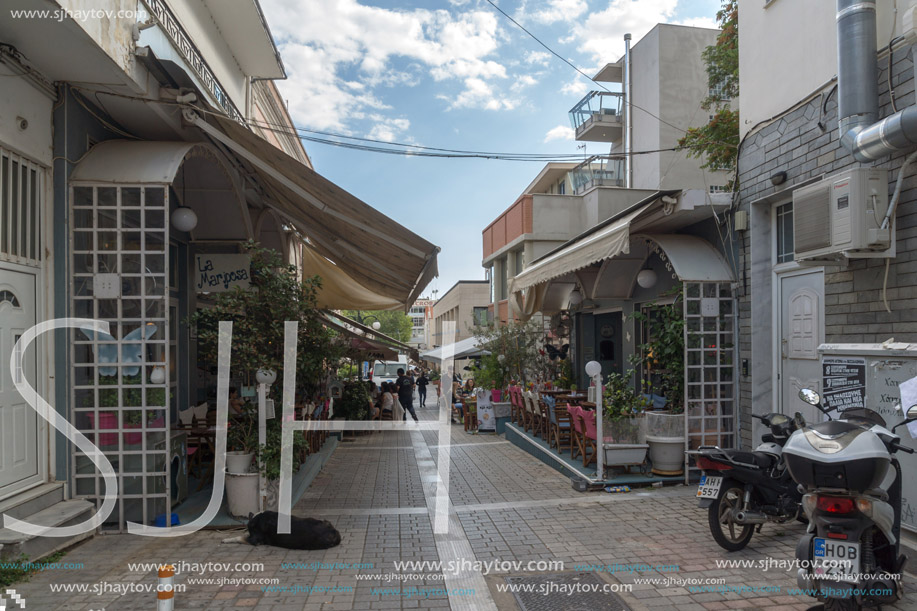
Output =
[{"x1": 185, "y1": 109, "x2": 439, "y2": 311}]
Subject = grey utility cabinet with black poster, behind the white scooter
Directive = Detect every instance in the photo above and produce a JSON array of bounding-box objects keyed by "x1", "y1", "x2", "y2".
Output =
[{"x1": 818, "y1": 342, "x2": 917, "y2": 532}]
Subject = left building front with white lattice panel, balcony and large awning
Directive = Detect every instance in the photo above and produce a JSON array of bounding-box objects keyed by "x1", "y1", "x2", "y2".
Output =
[{"x1": 0, "y1": 0, "x2": 436, "y2": 557}]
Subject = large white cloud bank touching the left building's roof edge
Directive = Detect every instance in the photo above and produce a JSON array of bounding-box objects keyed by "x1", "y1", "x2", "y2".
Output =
[{"x1": 263, "y1": 0, "x2": 515, "y2": 134}]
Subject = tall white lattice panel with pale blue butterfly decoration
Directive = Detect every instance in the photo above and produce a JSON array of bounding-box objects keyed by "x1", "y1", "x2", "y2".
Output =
[{"x1": 70, "y1": 184, "x2": 172, "y2": 531}]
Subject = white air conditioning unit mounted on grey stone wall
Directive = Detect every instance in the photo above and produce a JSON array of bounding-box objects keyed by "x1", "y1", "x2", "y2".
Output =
[{"x1": 793, "y1": 168, "x2": 895, "y2": 262}]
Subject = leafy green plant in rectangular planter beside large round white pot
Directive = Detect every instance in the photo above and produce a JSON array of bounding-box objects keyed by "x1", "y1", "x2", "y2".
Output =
[{"x1": 602, "y1": 370, "x2": 648, "y2": 465}]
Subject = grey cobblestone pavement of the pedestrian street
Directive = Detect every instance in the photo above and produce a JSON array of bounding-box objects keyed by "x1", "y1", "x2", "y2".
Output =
[{"x1": 15, "y1": 400, "x2": 917, "y2": 611}]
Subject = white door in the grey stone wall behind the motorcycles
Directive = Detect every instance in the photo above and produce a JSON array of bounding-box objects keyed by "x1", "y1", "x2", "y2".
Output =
[{"x1": 776, "y1": 268, "x2": 825, "y2": 422}]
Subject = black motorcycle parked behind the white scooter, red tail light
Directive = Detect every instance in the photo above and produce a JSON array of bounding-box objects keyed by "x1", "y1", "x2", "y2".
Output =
[{"x1": 688, "y1": 412, "x2": 806, "y2": 552}]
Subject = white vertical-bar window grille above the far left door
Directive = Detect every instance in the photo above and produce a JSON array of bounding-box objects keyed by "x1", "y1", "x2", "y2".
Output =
[{"x1": 0, "y1": 148, "x2": 45, "y2": 267}]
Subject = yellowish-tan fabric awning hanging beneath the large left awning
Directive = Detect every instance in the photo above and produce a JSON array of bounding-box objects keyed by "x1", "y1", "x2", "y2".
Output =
[{"x1": 302, "y1": 244, "x2": 401, "y2": 310}]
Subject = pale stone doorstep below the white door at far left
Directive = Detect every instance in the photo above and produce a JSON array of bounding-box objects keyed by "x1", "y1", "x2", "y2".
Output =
[{"x1": 0, "y1": 500, "x2": 96, "y2": 562}]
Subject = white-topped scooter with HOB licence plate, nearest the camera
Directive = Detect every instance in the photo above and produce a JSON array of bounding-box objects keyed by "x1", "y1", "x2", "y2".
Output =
[{"x1": 783, "y1": 389, "x2": 917, "y2": 611}]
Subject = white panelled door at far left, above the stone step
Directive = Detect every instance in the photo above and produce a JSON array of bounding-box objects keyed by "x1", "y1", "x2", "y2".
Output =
[{"x1": 0, "y1": 269, "x2": 39, "y2": 497}]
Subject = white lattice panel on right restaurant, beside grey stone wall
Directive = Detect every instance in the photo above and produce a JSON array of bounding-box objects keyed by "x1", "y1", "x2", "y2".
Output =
[{"x1": 684, "y1": 282, "x2": 738, "y2": 478}]
